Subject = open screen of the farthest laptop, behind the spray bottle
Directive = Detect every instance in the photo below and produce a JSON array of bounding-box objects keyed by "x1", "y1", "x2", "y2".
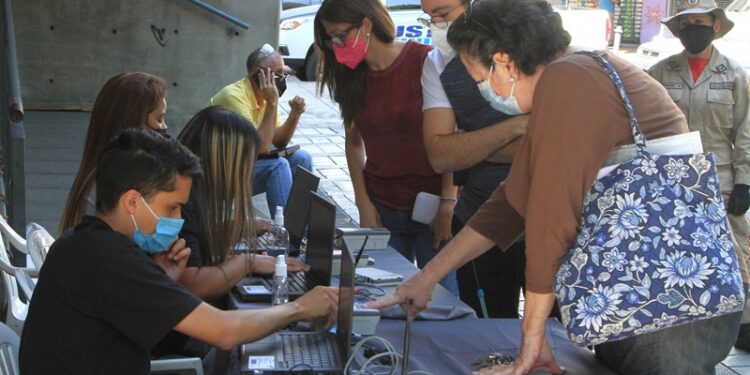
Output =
[{"x1": 284, "y1": 166, "x2": 318, "y2": 250}]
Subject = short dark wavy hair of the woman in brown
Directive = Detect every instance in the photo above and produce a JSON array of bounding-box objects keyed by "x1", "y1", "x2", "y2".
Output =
[{"x1": 448, "y1": 0, "x2": 570, "y2": 75}]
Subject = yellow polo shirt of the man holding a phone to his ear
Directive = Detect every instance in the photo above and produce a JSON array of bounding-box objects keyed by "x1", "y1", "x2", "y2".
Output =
[{"x1": 208, "y1": 76, "x2": 283, "y2": 129}]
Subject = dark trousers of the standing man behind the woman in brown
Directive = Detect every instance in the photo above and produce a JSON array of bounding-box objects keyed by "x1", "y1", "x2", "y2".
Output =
[{"x1": 452, "y1": 216, "x2": 526, "y2": 319}]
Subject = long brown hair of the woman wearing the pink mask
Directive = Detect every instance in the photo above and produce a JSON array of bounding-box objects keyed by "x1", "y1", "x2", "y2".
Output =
[{"x1": 314, "y1": 0, "x2": 396, "y2": 126}]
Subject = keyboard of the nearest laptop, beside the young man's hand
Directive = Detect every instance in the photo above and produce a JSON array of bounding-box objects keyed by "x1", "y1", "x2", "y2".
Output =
[{"x1": 279, "y1": 333, "x2": 336, "y2": 368}]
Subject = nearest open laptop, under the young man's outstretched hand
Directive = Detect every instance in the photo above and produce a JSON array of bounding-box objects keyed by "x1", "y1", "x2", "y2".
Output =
[{"x1": 240, "y1": 242, "x2": 354, "y2": 374}]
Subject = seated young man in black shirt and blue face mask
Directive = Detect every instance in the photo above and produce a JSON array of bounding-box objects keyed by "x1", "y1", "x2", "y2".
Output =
[{"x1": 20, "y1": 129, "x2": 338, "y2": 375}]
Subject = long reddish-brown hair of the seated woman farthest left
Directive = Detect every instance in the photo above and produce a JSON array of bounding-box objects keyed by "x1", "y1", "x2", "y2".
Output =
[{"x1": 60, "y1": 72, "x2": 167, "y2": 233}]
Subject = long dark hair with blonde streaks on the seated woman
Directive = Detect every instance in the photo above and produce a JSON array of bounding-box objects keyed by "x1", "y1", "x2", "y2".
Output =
[{"x1": 177, "y1": 107, "x2": 260, "y2": 265}]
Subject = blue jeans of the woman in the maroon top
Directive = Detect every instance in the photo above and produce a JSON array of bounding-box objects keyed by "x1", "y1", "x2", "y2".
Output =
[{"x1": 372, "y1": 201, "x2": 458, "y2": 296}]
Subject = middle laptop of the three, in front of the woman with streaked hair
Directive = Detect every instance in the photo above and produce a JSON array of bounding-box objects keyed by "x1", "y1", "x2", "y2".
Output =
[{"x1": 235, "y1": 192, "x2": 336, "y2": 303}]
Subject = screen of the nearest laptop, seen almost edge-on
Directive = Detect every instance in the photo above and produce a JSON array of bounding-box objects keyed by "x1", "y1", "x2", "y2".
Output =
[{"x1": 336, "y1": 245, "x2": 354, "y2": 358}]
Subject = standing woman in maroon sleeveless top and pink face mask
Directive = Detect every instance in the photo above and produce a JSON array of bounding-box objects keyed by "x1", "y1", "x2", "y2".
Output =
[{"x1": 315, "y1": 0, "x2": 456, "y2": 292}]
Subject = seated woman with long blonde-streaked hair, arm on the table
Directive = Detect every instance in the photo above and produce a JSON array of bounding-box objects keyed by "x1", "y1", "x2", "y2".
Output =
[{"x1": 177, "y1": 107, "x2": 304, "y2": 299}]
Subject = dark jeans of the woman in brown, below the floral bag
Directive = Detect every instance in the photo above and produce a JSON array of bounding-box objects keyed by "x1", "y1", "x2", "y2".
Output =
[{"x1": 596, "y1": 312, "x2": 742, "y2": 375}]
